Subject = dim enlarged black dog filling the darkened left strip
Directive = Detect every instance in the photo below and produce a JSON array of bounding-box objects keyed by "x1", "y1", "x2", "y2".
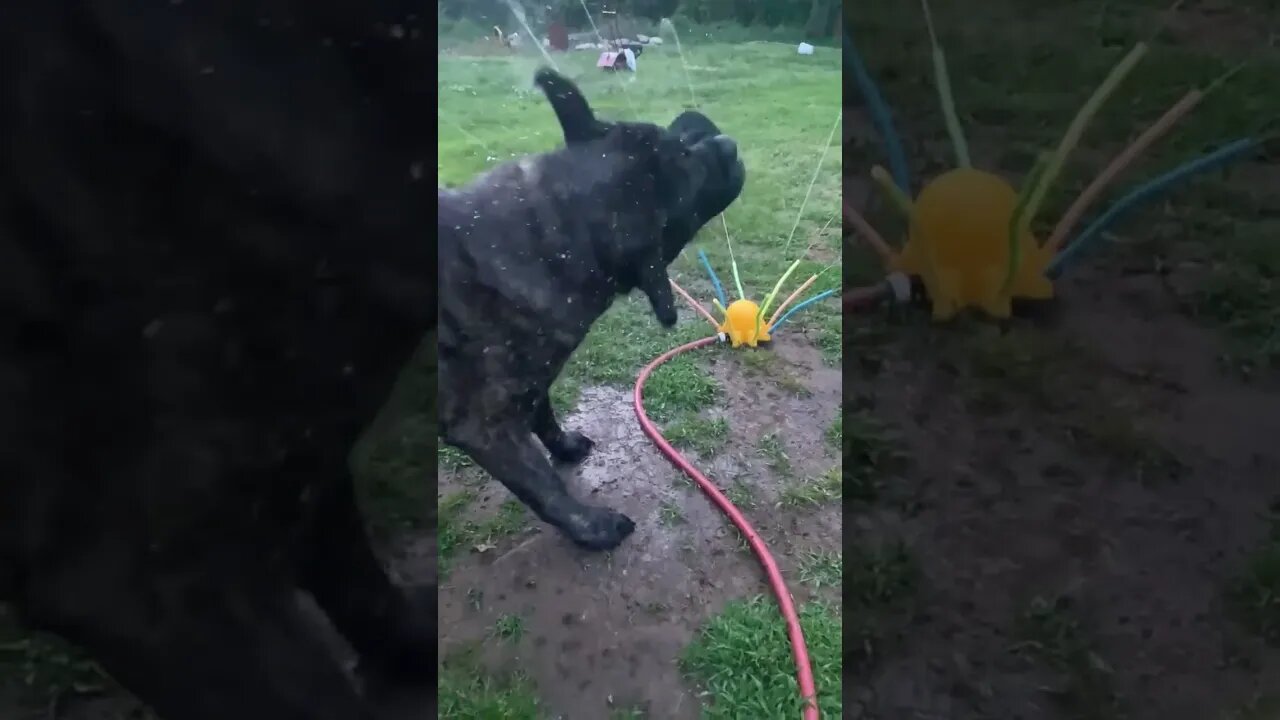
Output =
[{"x1": 0, "y1": 0, "x2": 438, "y2": 720}]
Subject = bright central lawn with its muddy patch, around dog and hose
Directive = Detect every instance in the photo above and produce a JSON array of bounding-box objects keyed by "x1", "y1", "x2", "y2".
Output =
[{"x1": 438, "y1": 28, "x2": 842, "y2": 719}]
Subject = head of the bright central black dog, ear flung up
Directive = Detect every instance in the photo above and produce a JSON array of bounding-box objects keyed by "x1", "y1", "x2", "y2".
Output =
[{"x1": 534, "y1": 68, "x2": 746, "y2": 264}]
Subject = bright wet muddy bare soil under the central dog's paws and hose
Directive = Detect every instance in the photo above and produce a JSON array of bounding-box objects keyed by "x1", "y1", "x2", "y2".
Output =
[{"x1": 439, "y1": 336, "x2": 842, "y2": 720}]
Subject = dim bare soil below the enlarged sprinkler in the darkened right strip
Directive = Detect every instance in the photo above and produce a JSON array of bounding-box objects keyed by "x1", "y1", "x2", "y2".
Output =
[{"x1": 845, "y1": 242, "x2": 1280, "y2": 720}]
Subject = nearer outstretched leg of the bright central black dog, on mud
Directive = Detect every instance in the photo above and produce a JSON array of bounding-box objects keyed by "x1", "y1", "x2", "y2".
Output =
[{"x1": 445, "y1": 420, "x2": 635, "y2": 550}]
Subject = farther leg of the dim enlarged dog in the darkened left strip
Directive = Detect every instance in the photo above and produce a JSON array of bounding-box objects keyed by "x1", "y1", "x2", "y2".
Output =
[{"x1": 301, "y1": 457, "x2": 436, "y2": 682}]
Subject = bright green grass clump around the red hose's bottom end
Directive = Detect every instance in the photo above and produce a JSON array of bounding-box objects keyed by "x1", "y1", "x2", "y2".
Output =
[{"x1": 681, "y1": 597, "x2": 842, "y2": 720}]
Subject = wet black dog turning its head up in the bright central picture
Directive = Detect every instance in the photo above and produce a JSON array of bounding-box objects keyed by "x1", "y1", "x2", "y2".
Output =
[{"x1": 438, "y1": 70, "x2": 745, "y2": 550}]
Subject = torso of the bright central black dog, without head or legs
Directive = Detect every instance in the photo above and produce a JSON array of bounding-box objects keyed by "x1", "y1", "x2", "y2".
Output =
[{"x1": 438, "y1": 147, "x2": 640, "y2": 419}]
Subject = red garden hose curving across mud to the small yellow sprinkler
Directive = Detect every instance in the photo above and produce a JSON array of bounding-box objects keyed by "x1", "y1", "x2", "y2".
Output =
[{"x1": 632, "y1": 336, "x2": 818, "y2": 720}]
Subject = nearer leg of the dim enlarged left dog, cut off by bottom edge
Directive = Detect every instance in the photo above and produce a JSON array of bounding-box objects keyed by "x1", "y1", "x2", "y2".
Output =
[{"x1": 23, "y1": 557, "x2": 375, "y2": 720}]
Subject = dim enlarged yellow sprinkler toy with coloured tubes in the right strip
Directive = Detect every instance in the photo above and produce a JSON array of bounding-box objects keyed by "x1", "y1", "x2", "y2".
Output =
[{"x1": 844, "y1": 0, "x2": 1262, "y2": 320}]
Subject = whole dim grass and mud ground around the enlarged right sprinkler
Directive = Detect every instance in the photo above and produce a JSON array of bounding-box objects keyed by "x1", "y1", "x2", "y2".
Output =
[{"x1": 844, "y1": 0, "x2": 1280, "y2": 720}]
